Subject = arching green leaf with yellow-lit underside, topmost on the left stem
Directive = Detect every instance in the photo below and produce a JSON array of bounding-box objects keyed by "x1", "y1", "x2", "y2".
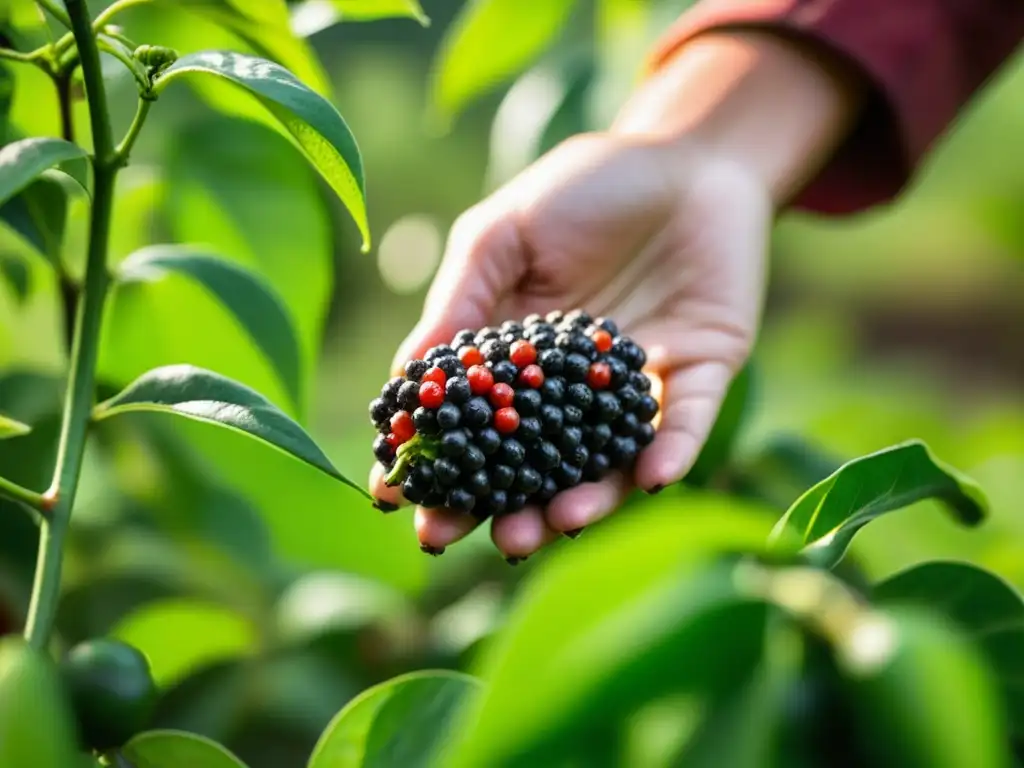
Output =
[{"x1": 154, "y1": 51, "x2": 371, "y2": 251}]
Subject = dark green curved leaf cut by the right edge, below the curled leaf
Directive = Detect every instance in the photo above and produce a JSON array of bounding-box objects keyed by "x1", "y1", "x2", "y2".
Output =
[{"x1": 872, "y1": 562, "x2": 1024, "y2": 738}]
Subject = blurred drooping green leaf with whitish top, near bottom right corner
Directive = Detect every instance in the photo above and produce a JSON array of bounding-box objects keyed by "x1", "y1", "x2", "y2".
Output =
[{"x1": 840, "y1": 606, "x2": 1012, "y2": 768}]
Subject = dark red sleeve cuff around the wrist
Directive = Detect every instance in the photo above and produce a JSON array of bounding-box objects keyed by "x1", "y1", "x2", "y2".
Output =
[{"x1": 650, "y1": 0, "x2": 1024, "y2": 214}]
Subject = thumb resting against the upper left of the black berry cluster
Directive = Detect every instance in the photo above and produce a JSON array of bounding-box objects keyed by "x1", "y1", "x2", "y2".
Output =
[{"x1": 391, "y1": 205, "x2": 526, "y2": 376}]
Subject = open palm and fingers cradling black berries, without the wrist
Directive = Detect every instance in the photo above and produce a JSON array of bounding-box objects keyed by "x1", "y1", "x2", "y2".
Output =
[{"x1": 372, "y1": 128, "x2": 771, "y2": 557}]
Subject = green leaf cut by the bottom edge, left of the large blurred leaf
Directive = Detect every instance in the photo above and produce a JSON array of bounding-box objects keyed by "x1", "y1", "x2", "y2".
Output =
[{"x1": 308, "y1": 671, "x2": 480, "y2": 768}]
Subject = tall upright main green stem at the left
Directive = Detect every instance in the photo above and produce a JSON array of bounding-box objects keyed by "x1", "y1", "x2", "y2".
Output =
[{"x1": 25, "y1": 0, "x2": 118, "y2": 648}]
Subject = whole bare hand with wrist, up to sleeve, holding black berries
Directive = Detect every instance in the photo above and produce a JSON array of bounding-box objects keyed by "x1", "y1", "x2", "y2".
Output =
[{"x1": 371, "y1": 33, "x2": 862, "y2": 558}]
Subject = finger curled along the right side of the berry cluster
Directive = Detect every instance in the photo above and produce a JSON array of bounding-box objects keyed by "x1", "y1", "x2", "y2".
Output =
[{"x1": 634, "y1": 361, "x2": 733, "y2": 492}]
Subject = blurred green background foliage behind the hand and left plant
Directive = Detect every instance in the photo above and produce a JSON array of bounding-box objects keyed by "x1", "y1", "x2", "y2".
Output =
[{"x1": 0, "y1": 0, "x2": 1024, "y2": 768}]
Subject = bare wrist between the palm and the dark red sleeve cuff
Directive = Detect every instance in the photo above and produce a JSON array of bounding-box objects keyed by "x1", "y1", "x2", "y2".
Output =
[{"x1": 611, "y1": 32, "x2": 863, "y2": 208}]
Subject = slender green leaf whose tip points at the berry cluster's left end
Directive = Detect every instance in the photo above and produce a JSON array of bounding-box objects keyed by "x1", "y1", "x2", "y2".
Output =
[{"x1": 94, "y1": 365, "x2": 370, "y2": 499}]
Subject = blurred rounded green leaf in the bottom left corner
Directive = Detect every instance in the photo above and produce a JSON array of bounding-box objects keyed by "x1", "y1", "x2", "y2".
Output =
[{"x1": 0, "y1": 635, "x2": 78, "y2": 768}]
